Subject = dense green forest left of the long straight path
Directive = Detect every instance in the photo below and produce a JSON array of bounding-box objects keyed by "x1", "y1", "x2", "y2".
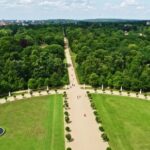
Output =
[{"x1": 0, "y1": 25, "x2": 68, "y2": 95}]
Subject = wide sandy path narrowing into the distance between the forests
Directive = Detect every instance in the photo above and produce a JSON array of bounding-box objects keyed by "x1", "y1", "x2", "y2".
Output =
[{"x1": 65, "y1": 38, "x2": 108, "y2": 150}]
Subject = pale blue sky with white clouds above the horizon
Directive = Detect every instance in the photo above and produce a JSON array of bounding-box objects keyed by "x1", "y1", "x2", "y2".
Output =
[{"x1": 0, "y1": 0, "x2": 150, "y2": 20}]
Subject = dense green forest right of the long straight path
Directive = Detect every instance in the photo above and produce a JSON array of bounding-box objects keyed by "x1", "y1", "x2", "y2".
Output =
[{"x1": 66, "y1": 23, "x2": 150, "y2": 92}]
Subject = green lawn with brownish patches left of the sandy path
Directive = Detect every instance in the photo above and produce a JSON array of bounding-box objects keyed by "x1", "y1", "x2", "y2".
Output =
[{"x1": 0, "y1": 95, "x2": 65, "y2": 150}]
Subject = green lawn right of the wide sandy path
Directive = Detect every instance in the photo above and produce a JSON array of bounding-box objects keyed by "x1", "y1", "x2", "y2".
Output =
[{"x1": 92, "y1": 94, "x2": 150, "y2": 150}]
